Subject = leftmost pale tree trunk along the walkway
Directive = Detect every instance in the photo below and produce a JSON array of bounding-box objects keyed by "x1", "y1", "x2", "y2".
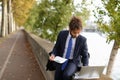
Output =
[{"x1": 1, "y1": 0, "x2": 7, "y2": 37}]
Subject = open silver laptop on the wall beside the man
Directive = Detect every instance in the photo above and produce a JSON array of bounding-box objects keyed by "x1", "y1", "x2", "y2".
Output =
[{"x1": 74, "y1": 66, "x2": 105, "y2": 79}]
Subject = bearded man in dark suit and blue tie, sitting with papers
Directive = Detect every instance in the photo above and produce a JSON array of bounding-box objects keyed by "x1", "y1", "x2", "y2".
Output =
[{"x1": 49, "y1": 16, "x2": 89, "y2": 80}]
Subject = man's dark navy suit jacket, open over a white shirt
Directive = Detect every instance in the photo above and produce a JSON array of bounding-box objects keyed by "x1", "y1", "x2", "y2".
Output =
[{"x1": 52, "y1": 30, "x2": 89, "y2": 66}]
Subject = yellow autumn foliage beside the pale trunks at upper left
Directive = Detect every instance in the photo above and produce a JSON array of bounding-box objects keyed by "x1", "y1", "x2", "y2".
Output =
[{"x1": 12, "y1": 0, "x2": 35, "y2": 26}]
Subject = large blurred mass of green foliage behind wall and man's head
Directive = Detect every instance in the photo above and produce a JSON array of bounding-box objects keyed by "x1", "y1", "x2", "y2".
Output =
[{"x1": 25, "y1": 0, "x2": 90, "y2": 42}]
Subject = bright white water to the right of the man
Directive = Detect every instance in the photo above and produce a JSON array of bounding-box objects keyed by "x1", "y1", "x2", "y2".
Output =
[{"x1": 82, "y1": 32, "x2": 120, "y2": 80}]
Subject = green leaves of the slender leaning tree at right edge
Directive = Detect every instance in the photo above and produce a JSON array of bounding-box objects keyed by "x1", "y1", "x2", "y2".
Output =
[{"x1": 97, "y1": 0, "x2": 120, "y2": 45}]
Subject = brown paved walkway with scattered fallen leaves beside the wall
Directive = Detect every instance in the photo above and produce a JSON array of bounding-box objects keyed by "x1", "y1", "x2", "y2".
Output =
[{"x1": 0, "y1": 31, "x2": 45, "y2": 80}]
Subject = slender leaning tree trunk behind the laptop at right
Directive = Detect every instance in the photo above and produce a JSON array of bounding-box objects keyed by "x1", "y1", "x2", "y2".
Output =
[{"x1": 106, "y1": 41, "x2": 119, "y2": 76}]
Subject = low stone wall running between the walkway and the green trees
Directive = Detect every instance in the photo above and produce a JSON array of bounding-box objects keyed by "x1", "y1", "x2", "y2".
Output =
[{"x1": 25, "y1": 31, "x2": 54, "y2": 80}]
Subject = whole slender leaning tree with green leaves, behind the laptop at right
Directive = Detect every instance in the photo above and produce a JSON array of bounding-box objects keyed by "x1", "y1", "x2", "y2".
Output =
[{"x1": 96, "y1": 0, "x2": 120, "y2": 76}]
